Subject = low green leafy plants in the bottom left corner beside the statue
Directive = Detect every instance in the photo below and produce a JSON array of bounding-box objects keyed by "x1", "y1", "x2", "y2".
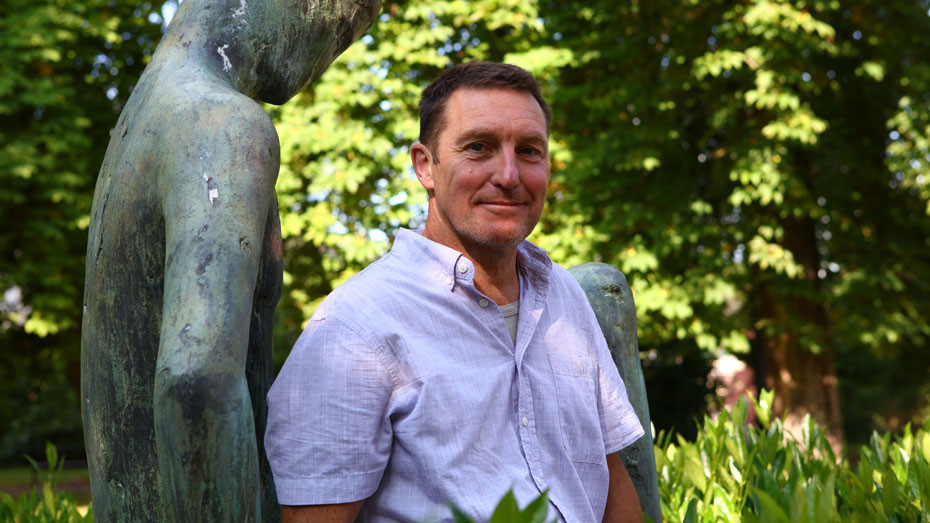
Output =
[{"x1": 0, "y1": 443, "x2": 94, "y2": 523}]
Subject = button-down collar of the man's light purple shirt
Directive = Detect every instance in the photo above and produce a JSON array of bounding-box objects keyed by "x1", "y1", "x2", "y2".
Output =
[{"x1": 391, "y1": 229, "x2": 552, "y2": 290}]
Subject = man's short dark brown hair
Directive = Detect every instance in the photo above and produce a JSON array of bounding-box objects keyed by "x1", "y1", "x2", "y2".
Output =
[{"x1": 420, "y1": 60, "x2": 552, "y2": 155}]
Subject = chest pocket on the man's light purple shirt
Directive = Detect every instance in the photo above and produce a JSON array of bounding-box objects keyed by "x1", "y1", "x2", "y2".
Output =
[{"x1": 549, "y1": 353, "x2": 606, "y2": 463}]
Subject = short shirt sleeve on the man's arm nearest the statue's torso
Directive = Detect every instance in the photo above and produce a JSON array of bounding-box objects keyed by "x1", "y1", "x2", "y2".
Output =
[{"x1": 265, "y1": 316, "x2": 393, "y2": 505}]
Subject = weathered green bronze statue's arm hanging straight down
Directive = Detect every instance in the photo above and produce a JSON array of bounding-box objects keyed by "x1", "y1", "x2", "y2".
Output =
[{"x1": 153, "y1": 102, "x2": 279, "y2": 521}]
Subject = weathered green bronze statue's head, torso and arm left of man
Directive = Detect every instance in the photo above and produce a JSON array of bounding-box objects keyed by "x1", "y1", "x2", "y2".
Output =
[{"x1": 81, "y1": 0, "x2": 380, "y2": 522}]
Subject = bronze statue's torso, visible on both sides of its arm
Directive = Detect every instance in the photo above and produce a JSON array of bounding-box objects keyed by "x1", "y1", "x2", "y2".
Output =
[{"x1": 81, "y1": 71, "x2": 282, "y2": 520}]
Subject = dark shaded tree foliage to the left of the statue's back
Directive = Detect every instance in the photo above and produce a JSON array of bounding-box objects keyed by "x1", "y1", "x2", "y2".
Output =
[{"x1": 0, "y1": 0, "x2": 161, "y2": 459}]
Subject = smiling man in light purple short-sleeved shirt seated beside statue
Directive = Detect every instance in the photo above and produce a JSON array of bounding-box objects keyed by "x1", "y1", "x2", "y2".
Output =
[{"x1": 266, "y1": 62, "x2": 643, "y2": 522}]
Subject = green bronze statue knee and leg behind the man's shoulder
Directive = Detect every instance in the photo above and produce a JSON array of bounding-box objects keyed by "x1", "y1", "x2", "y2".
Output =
[{"x1": 569, "y1": 263, "x2": 662, "y2": 522}]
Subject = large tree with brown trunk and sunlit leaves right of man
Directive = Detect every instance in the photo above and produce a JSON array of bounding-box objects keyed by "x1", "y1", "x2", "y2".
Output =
[{"x1": 532, "y1": 0, "x2": 930, "y2": 444}]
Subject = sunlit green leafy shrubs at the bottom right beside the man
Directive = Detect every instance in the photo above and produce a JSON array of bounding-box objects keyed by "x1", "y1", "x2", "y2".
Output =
[{"x1": 655, "y1": 391, "x2": 930, "y2": 522}]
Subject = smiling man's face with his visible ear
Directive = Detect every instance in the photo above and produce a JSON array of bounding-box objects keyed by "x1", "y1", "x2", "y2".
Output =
[{"x1": 411, "y1": 88, "x2": 549, "y2": 254}]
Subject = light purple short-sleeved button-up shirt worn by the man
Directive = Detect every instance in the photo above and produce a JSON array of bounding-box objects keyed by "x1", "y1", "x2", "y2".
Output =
[{"x1": 265, "y1": 230, "x2": 643, "y2": 522}]
